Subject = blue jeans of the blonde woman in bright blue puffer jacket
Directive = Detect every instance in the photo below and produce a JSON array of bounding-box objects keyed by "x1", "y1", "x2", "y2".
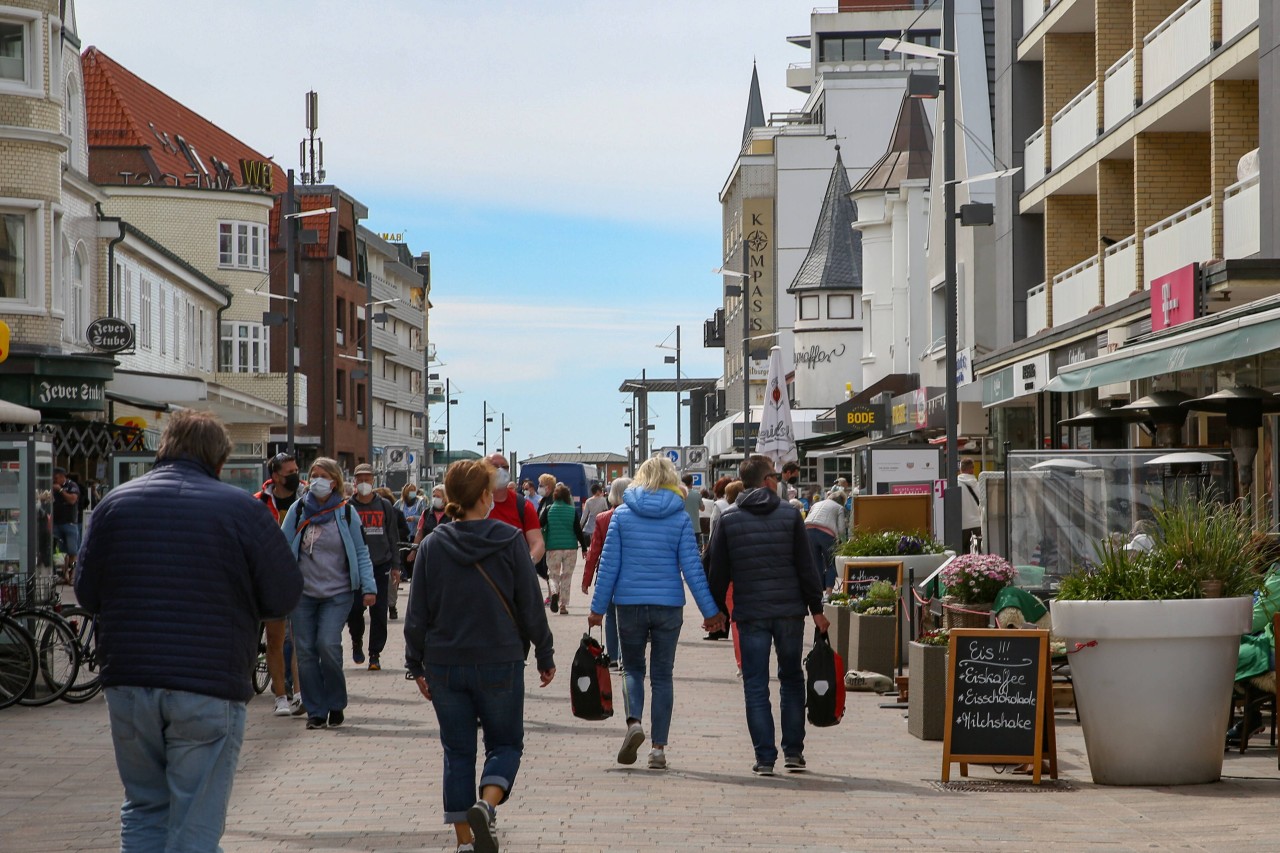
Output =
[{"x1": 617, "y1": 596, "x2": 685, "y2": 747}]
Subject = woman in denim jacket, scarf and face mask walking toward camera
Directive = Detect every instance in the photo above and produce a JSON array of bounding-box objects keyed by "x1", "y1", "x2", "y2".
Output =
[{"x1": 280, "y1": 456, "x2": 378, "y2": 729}]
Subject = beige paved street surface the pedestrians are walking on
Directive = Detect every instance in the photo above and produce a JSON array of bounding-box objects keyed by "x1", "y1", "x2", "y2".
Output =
[{"x1": 0, "y1": 584, "x2": 1280, "y2": 853}]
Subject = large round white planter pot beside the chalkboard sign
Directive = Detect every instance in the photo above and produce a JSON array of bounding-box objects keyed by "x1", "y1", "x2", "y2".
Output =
[{"x1": 1052, "y1": 598, "x2": 1252, "y2": 785}]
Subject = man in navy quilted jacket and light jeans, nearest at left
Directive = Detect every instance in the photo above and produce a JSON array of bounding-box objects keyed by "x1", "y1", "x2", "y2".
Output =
[{"x1": 76, "y1": 410, "x2": 302, "y2": 850}]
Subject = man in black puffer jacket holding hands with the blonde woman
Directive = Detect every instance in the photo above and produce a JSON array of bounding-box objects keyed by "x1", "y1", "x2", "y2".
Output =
[{"x1": 707, "y1": 456, "x2": 828, "y2": 776}]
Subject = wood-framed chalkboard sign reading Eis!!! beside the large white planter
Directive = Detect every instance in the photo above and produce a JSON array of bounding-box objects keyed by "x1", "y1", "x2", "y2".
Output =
[{"x1": 942, "y1": 629, "x2": 1057, "y2": 784}]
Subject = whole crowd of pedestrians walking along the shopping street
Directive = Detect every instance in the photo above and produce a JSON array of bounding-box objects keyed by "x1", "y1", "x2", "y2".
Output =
[{"x1": 74, "y1": 410, "x2": 840, "y2": 852}]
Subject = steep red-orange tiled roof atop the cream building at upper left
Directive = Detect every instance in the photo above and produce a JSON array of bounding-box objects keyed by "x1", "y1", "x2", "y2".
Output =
[{"x1": 81, "y1": 47, "x2": 285, "y2": 192}]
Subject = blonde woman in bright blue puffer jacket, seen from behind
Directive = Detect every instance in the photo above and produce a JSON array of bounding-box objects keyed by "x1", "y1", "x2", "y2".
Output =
[{"x1": 588, "y1": 456, "x2": 724, "y2": 770}]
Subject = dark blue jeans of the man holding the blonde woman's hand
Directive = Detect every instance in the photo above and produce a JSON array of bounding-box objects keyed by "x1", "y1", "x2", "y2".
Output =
[{"x1": 736, "y1": 616, "x2": 804, "y2": 765}]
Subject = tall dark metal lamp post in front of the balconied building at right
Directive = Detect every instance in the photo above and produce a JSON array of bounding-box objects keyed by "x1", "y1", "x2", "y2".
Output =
[{"x1": 942, "y1": 0, "x2": 964, "y2": 553}]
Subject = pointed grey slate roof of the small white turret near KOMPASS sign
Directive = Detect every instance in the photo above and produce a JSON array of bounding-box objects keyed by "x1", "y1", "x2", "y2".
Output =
[{"x1": 787, "y1": 145, "x2": 863, "y2": 293}]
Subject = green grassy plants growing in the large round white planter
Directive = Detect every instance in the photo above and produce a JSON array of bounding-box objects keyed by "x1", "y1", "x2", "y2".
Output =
[{"x1": 1057, "y1": 496, "x2": 1267, "y2": 601}]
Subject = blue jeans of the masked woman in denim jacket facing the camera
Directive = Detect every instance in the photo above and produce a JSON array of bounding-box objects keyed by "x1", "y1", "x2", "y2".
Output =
[{"x1": 289, "y1": 592, "x2": 355, "y2": 717}]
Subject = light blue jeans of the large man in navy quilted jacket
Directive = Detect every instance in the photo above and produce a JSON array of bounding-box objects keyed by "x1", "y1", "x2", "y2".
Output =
[{"x1": 105, "y1": 686, "x2": 244, "y2": 853}]
